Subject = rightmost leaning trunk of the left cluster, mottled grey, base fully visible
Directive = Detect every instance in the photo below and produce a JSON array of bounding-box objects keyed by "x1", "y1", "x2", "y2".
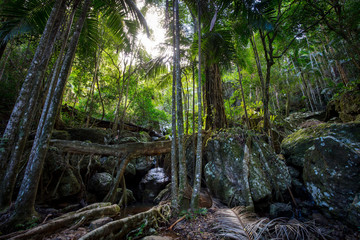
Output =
[{"x1": 8, "y1": 0, "x2": 92, "y2": 225}]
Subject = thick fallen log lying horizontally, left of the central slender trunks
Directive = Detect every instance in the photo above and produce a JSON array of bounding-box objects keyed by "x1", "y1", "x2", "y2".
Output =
[{"x1": 50, "y1": 139, "x2": 171, "y2": 157}]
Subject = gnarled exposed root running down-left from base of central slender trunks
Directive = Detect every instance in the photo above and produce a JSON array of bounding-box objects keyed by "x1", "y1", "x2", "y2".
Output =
[{"x1": 79, "y1": 204, "x2": 171, "y2": 240}]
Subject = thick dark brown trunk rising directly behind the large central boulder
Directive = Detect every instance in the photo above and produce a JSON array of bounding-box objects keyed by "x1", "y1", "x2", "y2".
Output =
[{"x1": 205, "y1": 63, "x2": 227, "y2": 130}]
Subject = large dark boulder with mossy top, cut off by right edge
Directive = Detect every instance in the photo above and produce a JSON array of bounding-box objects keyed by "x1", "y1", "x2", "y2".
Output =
[{"x1": 283, "y1": 123, "x2": 360, "y2": 225}]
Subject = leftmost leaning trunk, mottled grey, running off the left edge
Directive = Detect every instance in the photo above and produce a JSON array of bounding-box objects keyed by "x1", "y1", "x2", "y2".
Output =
[{"x1": 0, "y1": 0, "x2": 66, "y2": 179}]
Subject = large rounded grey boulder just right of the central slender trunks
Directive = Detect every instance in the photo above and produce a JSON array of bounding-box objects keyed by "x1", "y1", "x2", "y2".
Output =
[{"x1": 204, "y1": 132, "x2": 291, "y2": 207}]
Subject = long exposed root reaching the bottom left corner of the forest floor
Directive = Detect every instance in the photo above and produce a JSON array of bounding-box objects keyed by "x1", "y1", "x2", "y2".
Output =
[{"x1": 0, "y1": 203, "x2": 120, "y2": 240}]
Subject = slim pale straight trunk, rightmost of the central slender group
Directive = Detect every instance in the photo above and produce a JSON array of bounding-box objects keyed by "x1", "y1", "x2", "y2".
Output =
[{"x1": 191, "y1": 0, "x2": 203, "y2": 210}]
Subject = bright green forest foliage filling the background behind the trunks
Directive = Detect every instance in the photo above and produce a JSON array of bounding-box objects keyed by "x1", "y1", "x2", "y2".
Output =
[{"x1": 0, "y1": 0, "x2": 360, "y2": 133}]
